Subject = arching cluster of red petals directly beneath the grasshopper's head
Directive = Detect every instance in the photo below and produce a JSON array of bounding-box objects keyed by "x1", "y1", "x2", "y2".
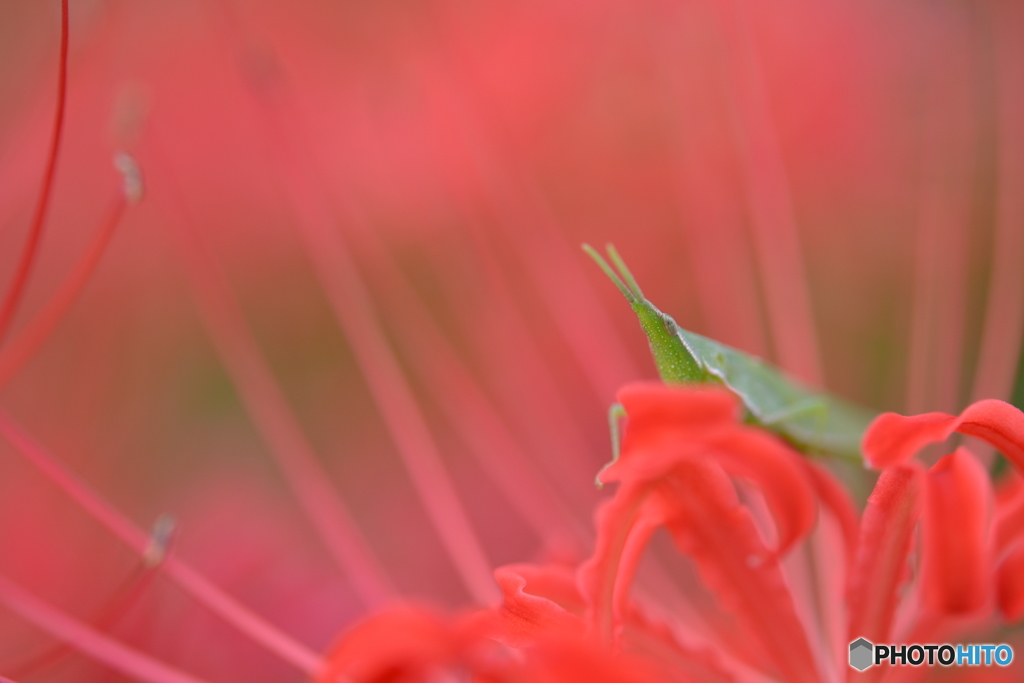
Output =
[{"x1": 582, "y1": 385, "x2": 815, "y2": 680}]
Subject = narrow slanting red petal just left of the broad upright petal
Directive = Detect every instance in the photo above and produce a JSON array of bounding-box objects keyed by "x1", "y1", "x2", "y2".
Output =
[{"x1": 847, "y1": 462, "x2": 925, "y2": 643}]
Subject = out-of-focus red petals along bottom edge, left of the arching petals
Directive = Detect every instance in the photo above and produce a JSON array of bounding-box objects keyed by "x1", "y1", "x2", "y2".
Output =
[{"x1": 317, "y1": 565, "x2": 730, "y2": 683}]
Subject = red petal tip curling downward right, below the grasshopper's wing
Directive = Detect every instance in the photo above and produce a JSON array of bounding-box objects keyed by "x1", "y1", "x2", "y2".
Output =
[{"x1": 709, "y1": 427, "x2": 817, "y2": 554}]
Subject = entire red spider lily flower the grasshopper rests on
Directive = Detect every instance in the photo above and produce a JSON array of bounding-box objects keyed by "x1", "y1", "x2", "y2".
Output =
[{"x1": 311, "y1": 384, "x2": 1024, "y2": 682}]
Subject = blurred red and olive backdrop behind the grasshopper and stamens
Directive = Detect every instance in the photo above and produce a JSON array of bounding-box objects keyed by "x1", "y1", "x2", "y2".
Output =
[{"x1": 0, "y1": 0, "x2": 1024, "y2": 681}]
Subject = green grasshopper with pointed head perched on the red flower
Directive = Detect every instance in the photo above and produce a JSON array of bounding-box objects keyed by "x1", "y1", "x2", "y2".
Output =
[{"x1": 583, "y1": 245, "x2": 874, "y2": 464}]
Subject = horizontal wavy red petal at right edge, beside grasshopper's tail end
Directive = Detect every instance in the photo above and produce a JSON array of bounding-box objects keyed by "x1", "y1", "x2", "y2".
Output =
[{"x1": 863, "y1": 398, "x2": 1024, "y2": 471}]
